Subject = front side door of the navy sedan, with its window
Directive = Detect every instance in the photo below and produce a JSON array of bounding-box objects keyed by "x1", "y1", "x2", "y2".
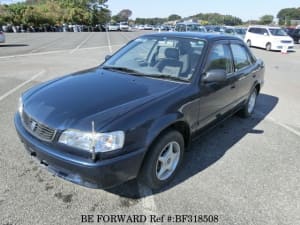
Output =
[{"x1": 199, "y1": 41, "x2": 237, "y2": 128}]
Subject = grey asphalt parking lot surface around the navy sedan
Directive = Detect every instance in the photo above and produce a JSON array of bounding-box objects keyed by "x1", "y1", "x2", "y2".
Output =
[{"x1": 0, "y1": 31, "x2": 300, "y2": 225}]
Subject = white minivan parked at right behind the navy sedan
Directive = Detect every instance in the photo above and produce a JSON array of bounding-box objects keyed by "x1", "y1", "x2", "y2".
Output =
[{"x1": 244, "y1": 26, "x2": 294, "y2": 51}]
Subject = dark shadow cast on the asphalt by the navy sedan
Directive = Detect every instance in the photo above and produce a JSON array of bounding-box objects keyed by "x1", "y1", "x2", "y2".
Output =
[{"x1": 106, "y1": 94, "x2": 279, "y2": 199}]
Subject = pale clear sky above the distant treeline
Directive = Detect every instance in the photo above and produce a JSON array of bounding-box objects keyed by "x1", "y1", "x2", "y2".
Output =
[{"x1": 0, "y1": 0, "x2": 300, "y2": 21}]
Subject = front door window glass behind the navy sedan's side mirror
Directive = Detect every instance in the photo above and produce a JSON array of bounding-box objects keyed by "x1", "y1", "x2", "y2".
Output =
[{"x1": 206, "y1": 44, "x2": 233, "y2": 73}]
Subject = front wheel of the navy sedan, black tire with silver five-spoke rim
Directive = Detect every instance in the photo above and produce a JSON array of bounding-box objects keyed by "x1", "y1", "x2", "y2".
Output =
[{"x1": 138, "y1": 130, "x2": 184, "y2": 190}]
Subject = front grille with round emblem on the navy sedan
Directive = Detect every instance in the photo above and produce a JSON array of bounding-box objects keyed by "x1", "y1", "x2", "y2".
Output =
[{"x1": 22, "y1": 111, "x2": 56, "y2": 142}]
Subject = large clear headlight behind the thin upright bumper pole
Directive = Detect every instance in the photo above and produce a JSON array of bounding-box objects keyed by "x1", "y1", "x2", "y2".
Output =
[{"x1": 58, "y1": 130, "x2": 125, "y2": 152}]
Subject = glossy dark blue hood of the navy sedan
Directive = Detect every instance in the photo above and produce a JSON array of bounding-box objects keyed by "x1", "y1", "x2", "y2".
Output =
[{"x1": 23, "y1": 69, "x2": 183, "y2": 130}]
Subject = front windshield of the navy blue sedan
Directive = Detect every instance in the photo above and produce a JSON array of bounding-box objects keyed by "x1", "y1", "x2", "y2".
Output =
[{"x1": 102, "y1": 36, "x2": 205, "y2": 81}]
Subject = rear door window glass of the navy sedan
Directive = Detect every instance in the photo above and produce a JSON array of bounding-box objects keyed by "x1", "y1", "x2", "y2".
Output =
[{"x1": 230, "y1": 44, "x2": 251, "y2": 71}]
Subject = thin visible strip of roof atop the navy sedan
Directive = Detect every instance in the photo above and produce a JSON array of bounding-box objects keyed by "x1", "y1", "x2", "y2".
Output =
[{"x1": 143, "y1": 32, "x2": 241, "y2": 41}]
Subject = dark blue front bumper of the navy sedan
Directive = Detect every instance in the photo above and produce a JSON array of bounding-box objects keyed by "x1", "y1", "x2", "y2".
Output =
[{"x1": 14, "y1": 113, "x2": 146, "y2": 188}]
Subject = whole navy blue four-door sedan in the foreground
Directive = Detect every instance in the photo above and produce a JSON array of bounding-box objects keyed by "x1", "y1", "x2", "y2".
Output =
[{"x1": 14, "y1": 32, "x2": 264, "y2": 189}]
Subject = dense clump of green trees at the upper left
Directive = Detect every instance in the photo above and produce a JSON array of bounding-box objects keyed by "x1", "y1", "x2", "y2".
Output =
[{"x1": 0, "y1": 0, "x2": 110, "y2": 26}]
